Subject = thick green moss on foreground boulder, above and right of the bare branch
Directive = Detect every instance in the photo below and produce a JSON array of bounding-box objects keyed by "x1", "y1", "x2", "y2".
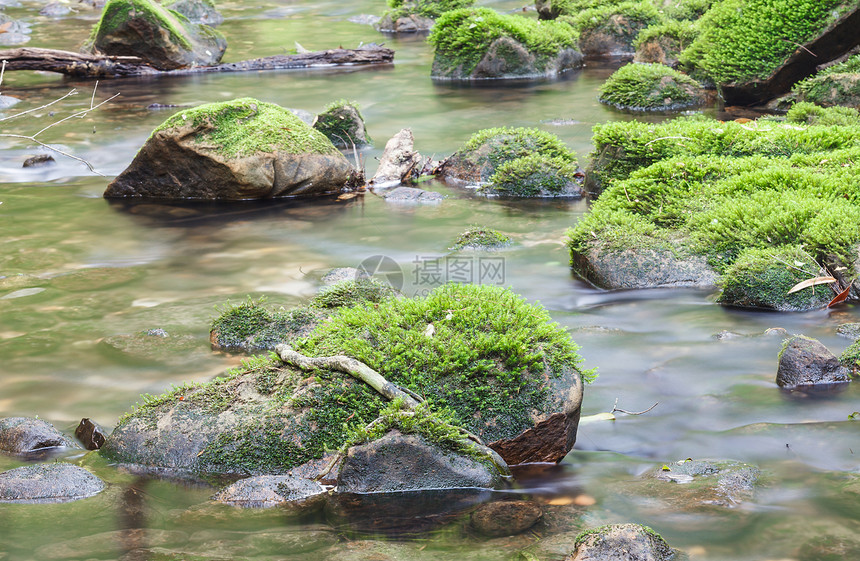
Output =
[{"x1": 297, "y1": 284, "x2": 595, "y2": 441}]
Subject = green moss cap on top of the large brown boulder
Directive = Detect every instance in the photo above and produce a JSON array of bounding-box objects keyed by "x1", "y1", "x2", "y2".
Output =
[{"x1": 152, "y1": 97, "x2": 338, "y2": 156}]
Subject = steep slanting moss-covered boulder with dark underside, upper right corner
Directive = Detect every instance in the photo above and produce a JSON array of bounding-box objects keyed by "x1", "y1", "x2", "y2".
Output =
[{"x1": 681, "y1": 0, "x2": 860, "y2": 105}]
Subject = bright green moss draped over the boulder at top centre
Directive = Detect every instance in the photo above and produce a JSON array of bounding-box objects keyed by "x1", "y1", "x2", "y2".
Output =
[{"x1": 427, "y1": 8, "x2": 577, "y2": 75}]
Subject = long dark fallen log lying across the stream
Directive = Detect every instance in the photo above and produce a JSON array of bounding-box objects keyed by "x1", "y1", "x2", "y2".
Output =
[{"x1": 0, "y1": 45, "x2": 394, "y2": 79}]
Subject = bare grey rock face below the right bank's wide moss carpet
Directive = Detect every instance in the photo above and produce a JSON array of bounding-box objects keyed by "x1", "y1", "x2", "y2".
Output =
[{"x1": 573, "y1": 241, "x2": 718, "y2": 289}]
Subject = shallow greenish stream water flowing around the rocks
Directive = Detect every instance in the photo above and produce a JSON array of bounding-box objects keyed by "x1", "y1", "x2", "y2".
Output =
[{"x1": 0, "y1": 0, "x2": 860, "y2": 560}]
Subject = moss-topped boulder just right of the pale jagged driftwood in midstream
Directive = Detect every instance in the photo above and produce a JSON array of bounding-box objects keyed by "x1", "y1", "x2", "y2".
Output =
[{"x1": 436, "y1": 127, "x2": 583, "y2": 197}]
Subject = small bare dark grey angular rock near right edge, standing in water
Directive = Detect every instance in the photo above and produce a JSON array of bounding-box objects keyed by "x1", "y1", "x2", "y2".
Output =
[{"x1": 776, "y1": 336, "x2": 851, "y2": 388}]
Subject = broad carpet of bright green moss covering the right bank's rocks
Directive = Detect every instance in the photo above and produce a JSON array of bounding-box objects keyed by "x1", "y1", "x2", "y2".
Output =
[{"x1": 569, "y1": 107, "x2": 860, "y2": 310}]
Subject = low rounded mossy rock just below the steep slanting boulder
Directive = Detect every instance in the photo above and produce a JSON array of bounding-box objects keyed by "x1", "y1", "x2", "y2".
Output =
[{"x1": 598, "y1": 64, "x2": 703, "y2": 111}]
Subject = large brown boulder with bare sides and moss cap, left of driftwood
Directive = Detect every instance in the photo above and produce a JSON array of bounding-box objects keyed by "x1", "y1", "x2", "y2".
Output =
[{"x1": 105, "y1": 98, "x2": 353, "y2": 201}]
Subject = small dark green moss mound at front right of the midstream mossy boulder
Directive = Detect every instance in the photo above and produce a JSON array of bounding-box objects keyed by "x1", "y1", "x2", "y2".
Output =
[{"x1": 482, "y1": 153, "x2": 580, "y2": 197}]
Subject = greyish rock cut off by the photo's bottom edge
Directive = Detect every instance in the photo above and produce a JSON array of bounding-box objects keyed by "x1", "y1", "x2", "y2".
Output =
[{"x1": 565, "y1": 524, "x2": 677, "y2": 561}]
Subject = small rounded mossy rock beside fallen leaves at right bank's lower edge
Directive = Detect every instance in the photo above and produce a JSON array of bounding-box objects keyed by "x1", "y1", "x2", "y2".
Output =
[{"x1": 719, "y1": 246, "x2": 833, "y2": 311}]
